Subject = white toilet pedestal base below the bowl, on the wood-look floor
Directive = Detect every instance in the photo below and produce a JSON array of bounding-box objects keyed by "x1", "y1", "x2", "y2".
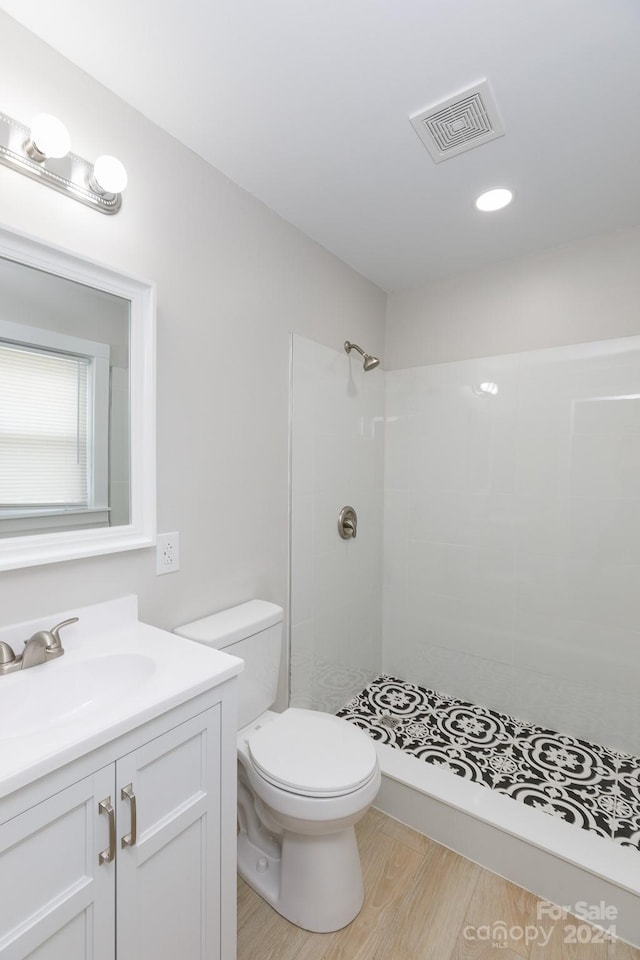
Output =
[{"x1": 238, "y1": 826, "x2": 364, "y2": 933}]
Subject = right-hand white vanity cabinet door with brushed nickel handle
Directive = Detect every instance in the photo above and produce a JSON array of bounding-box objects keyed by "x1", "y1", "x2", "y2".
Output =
[{"x1": 116, "y1": 706, "x2": 220, "y2": 960}]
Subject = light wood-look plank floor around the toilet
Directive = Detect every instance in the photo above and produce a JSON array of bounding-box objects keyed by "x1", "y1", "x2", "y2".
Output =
[{"x1": 238, "y1": 810, "x2": 640, "y2": 960}]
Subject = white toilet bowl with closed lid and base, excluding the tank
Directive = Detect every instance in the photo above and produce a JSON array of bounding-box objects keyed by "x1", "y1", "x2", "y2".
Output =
[{"x1": 238, "y1": 708, "x2": 380, "y2": 933}]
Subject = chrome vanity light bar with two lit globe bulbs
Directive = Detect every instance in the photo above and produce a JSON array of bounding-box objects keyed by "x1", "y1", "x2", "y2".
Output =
[{"x1": 0, "y1": 113, "x2": 127, "y2": 214}]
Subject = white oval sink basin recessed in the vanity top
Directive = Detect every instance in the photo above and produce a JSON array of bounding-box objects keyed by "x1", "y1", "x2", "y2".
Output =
[{"x1": 0, "y1": 653, "x2": 156, "y2": 740}]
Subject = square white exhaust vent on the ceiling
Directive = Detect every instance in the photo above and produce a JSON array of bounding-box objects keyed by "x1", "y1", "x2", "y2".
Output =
[{"x1": 409, "y1": 80, "x2": 504, "y2": 163}]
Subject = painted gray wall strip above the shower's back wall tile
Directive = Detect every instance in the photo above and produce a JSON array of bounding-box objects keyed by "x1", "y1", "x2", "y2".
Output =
[{"x1": 385, "y1": 228, "x2": 640, "y2": 370}]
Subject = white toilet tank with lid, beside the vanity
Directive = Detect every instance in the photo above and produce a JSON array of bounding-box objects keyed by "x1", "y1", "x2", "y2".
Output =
[{"x1": 174, "y1": 600, "x2": 282, "y2": 729}]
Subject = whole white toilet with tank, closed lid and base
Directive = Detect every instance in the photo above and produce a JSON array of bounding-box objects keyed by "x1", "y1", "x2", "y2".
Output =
[{"x1": 176, "y1": 600, "x2": 380, "y2": 933}]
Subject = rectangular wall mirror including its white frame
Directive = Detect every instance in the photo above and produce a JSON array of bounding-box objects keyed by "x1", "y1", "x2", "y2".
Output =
[{"x1": 0, "y1": 228, "x2": 155, "y2": 570}]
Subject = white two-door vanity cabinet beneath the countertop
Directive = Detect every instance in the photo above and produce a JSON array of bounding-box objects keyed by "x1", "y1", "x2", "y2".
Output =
[{"x1": 0, "y1": 683, "x2": 235, "y2": 960}]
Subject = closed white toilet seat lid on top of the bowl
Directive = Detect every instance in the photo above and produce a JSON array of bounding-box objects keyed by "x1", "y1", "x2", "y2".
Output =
[{"x1": 246, "y1": 707, "x2": 378, "y2": 798}]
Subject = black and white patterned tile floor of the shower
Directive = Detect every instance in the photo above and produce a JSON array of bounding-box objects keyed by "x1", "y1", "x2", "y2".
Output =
[{"x1": 338, "y1": 676, "x2": 640, "y2": 850}]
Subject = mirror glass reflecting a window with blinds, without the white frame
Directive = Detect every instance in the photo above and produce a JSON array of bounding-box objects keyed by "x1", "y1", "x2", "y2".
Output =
[{"x1": 0, "y1": 257, "x2": 131, "y2": 537}]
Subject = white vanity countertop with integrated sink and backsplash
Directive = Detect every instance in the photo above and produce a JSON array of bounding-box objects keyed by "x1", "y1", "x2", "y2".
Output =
[{"x1": 0, "y1": 597, "x2": 243, "y2": 798}]
